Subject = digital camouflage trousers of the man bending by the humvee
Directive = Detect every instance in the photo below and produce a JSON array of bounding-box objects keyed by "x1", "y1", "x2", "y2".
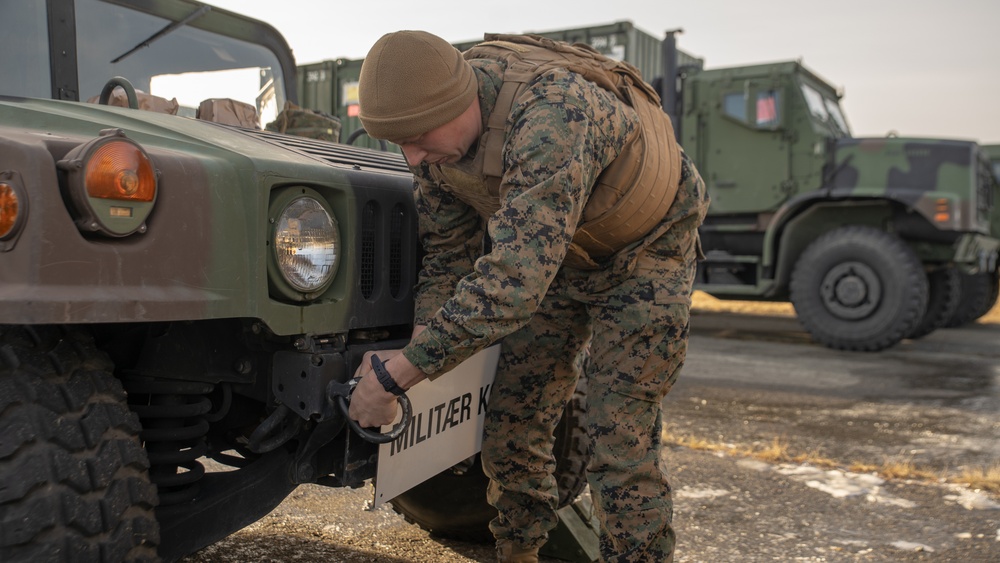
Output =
[{"x1": 482, "y1": 208, "x2": 698, "y2": 562}]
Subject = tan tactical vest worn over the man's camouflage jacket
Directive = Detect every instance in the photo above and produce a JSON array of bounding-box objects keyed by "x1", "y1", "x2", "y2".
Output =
[{"x1": 431, "y1": 34, "x2": 681, "y2": 269}]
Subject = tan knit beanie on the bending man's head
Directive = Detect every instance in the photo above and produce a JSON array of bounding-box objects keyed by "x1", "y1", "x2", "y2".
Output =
[{"x1": 358, "y1": 31, "x2": 479, "y2": 141}]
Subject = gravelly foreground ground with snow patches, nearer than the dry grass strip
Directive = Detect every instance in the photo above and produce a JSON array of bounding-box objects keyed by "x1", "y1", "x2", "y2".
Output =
[{"x1": 183, "y1": 448, "x2": 1000, "y2": 563}]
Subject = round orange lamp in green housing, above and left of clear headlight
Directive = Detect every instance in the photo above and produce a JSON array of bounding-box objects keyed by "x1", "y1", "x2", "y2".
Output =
[{"x1": 58, "y1": 129, "x2": 157, "y2": 237}]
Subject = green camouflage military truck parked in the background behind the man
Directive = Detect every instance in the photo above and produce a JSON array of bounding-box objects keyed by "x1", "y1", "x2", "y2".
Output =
[{"x1": 440, "y1": 21, "x2": 1000, "y2": 351}]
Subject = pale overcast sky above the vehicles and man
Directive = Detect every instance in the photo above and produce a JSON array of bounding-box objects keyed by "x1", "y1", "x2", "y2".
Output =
[{"x1": 205, "y1": 0, "x2": 1000, "y2": 144}]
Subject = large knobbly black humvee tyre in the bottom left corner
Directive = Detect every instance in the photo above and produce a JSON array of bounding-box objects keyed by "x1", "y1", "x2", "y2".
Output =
[{"x1": 0, "y1": 326, "x2": 159, "y2": 562}]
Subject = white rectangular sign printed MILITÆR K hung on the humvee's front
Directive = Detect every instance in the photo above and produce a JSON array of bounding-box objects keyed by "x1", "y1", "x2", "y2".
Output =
[{"x1": 374, "y1": 345, "x2": 500, "y2": 507}]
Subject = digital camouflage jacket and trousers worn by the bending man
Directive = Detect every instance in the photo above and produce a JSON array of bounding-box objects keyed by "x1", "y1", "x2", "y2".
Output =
[{"x1": 352, "y1": 32, "x2": 709, "y2": 562}]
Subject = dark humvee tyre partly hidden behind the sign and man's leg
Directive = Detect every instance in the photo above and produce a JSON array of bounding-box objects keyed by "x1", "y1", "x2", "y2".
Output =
[{"x1": 390, "y1": 377, "x2": 591, "y2": 543}]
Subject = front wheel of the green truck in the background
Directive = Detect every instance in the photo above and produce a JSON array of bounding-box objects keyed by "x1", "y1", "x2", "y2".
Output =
[{"x1": 791, "y1": 226, "x2": 928, "y2": 352}]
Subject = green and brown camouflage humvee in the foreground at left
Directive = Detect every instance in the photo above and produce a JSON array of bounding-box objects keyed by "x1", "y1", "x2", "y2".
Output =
[{"x1": 0, "y1": 0, "x2": 583, "y2": 562}]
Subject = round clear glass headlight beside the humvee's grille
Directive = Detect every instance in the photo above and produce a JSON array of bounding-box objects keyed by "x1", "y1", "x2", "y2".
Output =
[{"x1": 273, "y1": 192, "x2": 341, "y2": 298}]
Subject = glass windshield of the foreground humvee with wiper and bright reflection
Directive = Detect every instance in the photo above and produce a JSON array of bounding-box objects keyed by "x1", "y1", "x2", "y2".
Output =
[{"x1": 0, "y1": 0, "x2": 285, "y2": 126}]
